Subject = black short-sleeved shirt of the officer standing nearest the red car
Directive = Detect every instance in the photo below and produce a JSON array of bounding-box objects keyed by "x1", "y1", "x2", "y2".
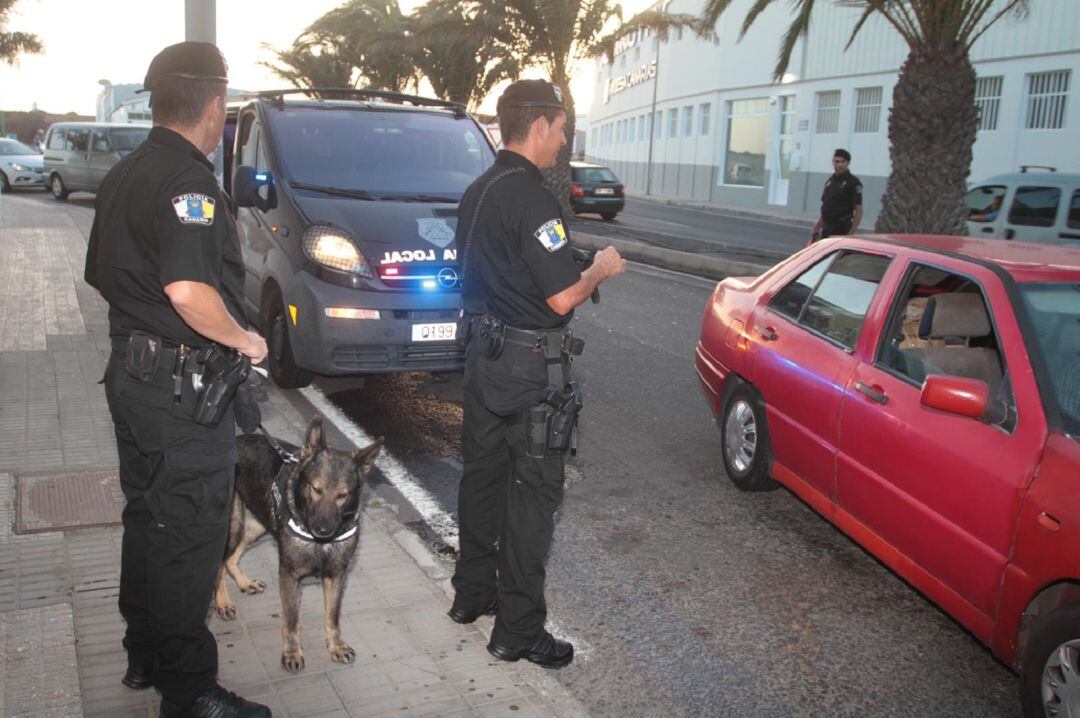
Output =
[{"x1": 455, "y1": 150, "x2": 581, "y2": 329}]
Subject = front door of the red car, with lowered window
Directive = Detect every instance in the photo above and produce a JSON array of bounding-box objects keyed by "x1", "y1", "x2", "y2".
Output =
[{"x1": 837, "y1": 257, "x2": 1045, "y2": 626}]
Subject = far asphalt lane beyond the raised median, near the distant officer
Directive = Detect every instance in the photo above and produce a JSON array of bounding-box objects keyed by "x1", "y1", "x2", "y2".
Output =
[{"x1": 571, "y1": 199, "x2": 809, "y2": 263}]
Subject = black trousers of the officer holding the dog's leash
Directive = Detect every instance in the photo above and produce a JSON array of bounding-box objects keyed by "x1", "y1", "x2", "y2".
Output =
[{"x1": 105, "y1": 349, "x2": 237, "y2": 708}]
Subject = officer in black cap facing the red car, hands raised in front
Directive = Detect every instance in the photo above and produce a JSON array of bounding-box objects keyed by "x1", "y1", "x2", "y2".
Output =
[{"x1": 448, "y1": 80, "x2": 625, "y2": 668}]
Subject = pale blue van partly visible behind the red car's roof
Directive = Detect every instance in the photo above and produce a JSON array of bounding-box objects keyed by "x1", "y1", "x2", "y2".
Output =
[{"x1": 966, "y1": 166, "x2": 1080, "y2": 245}]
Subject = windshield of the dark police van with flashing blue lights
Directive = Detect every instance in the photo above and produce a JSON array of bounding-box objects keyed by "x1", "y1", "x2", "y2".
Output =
[{"x1": 271, "y1": 108, "x2": 495, "y2": 202}]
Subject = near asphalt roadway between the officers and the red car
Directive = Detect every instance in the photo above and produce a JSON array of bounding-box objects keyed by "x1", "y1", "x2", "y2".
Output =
[{"x1": 29, "y1": 188, "x2": 1020, "y2": 718}]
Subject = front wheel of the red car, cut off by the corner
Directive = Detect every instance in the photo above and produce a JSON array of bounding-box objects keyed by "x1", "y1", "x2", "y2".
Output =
[{"x1": 1020, "y1": 604, "x2": 1080, "y2": 718}]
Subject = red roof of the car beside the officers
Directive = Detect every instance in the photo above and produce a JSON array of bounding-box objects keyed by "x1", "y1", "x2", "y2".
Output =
[{"x1": 838, "y1": 234, "x2": 1080, "y2": 282}]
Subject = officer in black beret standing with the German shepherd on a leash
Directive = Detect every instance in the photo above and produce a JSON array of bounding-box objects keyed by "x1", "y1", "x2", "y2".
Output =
[{"x1": 85, "y1": 42, "x2": 270, "y2": 718}]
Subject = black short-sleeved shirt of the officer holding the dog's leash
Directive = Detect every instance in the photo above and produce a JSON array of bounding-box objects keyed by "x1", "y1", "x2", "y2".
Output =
[{"x1": 84, "y1": 127, "x2": 246, "y2": 347}]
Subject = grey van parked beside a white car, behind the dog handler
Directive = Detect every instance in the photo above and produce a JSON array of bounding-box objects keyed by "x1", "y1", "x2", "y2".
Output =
[{"x1": 45, "y1": 122, "x2": 150, "y2": 200}]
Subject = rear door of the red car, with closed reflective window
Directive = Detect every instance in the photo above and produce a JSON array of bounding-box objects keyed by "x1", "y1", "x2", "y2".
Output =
[{"x1": 747, "y1": 250, "x2": 890, "y2": 499}]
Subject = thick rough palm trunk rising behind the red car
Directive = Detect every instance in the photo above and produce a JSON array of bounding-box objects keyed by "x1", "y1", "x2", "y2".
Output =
[{"x1": 875, "y1": 45, "x2": 978, "y2": 234}]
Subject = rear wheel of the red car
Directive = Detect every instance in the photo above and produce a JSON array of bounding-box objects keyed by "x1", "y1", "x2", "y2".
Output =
[{"x1": 720, "y1": 384, "x2": 780, "y2": 491}]
